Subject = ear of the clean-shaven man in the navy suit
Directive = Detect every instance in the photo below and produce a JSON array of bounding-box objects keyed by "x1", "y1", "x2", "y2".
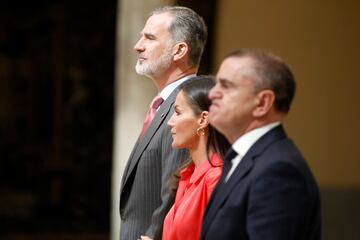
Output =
[{"x1": 253, "y1": 90, "x2": 275, "y2": 118}]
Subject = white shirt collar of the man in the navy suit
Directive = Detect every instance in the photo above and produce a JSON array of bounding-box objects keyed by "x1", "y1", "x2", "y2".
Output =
[{"x1": 232, "y1": 122, "x2": 280, "y2": 157}]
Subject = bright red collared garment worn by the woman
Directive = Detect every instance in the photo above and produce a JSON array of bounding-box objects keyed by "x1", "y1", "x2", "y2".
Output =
[{"x1": 163, "y1": 154, "x2": 222, "y2": 240}]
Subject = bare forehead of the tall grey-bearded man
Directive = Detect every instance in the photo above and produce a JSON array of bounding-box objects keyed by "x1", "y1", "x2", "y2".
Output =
[{"x1": 142, "y1": 12, "x2": 173, "y2": 34}]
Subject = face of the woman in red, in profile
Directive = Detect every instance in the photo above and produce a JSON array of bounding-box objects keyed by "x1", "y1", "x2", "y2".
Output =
[{"x1": 168, "y1": 91, "x2": 201, "y2": 149}]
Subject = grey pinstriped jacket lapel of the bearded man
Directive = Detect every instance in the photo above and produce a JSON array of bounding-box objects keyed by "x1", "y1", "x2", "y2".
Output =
[{"x1": 123, "y1": 90, "x2": 178, "y2": 186}]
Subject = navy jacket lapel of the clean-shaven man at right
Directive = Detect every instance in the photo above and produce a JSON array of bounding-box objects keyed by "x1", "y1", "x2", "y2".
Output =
[{"x1": 203, "y1": 125, "x2": 286, "y2": 232}]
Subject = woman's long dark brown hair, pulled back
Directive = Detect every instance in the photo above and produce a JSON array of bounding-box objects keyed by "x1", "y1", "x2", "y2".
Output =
[{"x1": 170, "y1": 76, "x2": 230, "y2": 195}]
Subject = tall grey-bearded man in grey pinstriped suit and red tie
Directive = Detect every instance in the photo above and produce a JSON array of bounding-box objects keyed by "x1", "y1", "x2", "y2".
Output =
[{"x1": 120, "y1": 6, "x2": 207, "y2": 240}]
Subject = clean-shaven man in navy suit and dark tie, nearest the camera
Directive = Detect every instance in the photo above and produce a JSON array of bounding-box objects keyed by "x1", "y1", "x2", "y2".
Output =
[{"x1": 201, "y1": 50, "x2": 321, "y2": 240}]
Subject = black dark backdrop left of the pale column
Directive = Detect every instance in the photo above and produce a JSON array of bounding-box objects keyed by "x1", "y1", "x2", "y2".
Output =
[{"x1": 0, "y1": 0, "x2": 116, "y2": 239}]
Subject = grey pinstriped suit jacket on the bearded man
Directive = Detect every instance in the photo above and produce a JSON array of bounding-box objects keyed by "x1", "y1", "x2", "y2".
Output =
[{"x1": 120, "y1": 87, "x2": 188, "y2": 240}]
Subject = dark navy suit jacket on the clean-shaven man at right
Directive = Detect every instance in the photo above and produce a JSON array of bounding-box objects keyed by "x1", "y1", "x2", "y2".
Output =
[{"x1": 201, "y1": 126, "x2": 321, "y2": 240}]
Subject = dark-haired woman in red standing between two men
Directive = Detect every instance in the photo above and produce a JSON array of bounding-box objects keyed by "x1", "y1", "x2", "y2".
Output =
[{"x1": 163, "y1": 76, "x2": 230, "y2": 240}]
